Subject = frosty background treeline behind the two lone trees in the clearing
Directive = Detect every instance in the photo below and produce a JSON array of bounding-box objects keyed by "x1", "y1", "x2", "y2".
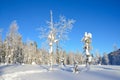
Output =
[{"x1": 0, "y1": 21, "x2": 109, "y2": 65}]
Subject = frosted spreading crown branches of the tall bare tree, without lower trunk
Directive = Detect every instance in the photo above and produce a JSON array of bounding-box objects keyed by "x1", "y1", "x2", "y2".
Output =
[{"x1": 38, "y1": 12, "x2": 75, "y2": 42}]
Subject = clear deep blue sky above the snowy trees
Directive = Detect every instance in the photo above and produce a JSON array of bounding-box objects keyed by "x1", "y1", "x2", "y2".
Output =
[{"x1": 0, "y1": 0, "x2": 120, "y2": 54}]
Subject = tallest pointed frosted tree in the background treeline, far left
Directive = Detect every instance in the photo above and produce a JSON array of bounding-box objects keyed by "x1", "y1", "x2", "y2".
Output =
[{"x1": 4, "y1": 21, "x2": 22, "y2": 63}]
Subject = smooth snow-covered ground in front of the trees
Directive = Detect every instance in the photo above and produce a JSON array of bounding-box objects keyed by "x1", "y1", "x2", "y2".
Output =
[{"x1": 0, "y1": 65, "x2": 120, "y2": 80}]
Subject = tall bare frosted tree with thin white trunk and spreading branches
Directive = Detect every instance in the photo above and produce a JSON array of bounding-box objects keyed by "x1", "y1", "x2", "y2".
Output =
[{"x1": 40, "y1": 11, "x2": 75, "y2": 68}]
